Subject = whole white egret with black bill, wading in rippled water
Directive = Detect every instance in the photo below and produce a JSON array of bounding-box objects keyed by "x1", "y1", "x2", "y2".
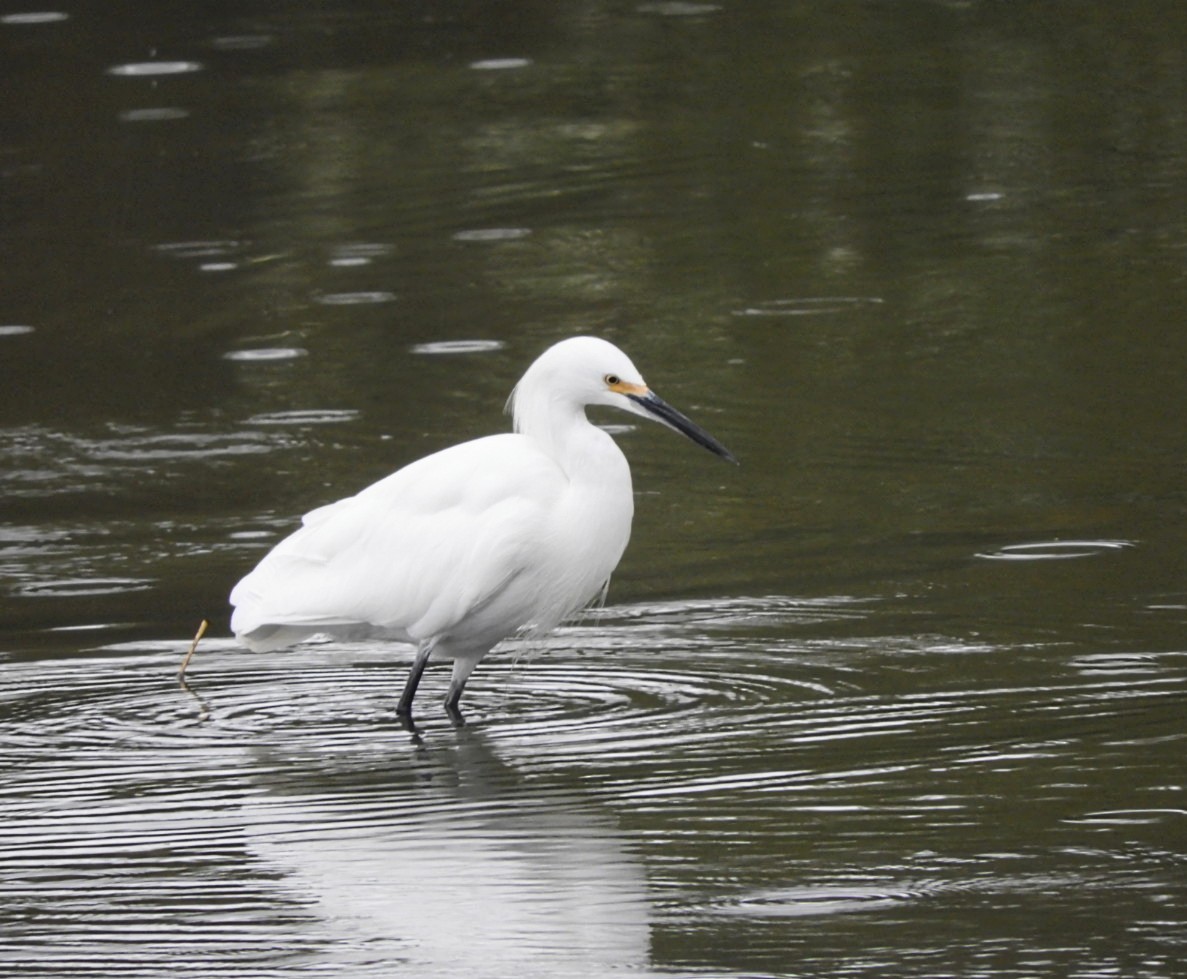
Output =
[{"x1": 230, "y1": 337, "x2": 737, "y2": 718}]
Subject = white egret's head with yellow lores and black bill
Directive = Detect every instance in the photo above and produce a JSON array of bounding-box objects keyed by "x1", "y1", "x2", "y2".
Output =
[{"x1": 509, "y1": 337, "x2": 737, "y2": 463}]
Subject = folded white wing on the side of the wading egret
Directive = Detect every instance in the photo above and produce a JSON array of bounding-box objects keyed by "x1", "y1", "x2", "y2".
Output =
[{"x1": 230, "y1": 434, "x2": 569, "y2": 649}]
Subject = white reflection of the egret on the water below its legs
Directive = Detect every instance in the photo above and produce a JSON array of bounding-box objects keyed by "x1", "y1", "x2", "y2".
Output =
[{"x1": 243, "y1": 732, "x2": 650, "y2": 979}]
